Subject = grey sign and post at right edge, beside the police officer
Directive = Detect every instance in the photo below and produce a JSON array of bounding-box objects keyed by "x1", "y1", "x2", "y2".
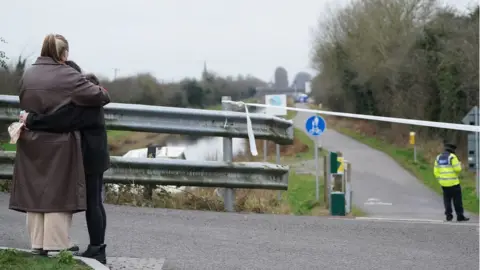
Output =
[{"x1": 462, "y1": 106, "x2": 480, "y2": 197}]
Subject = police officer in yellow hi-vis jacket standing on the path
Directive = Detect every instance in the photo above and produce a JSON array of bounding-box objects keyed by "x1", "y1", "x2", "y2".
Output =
[{"x1": 433, "y1": 143, "x2": 469, "y2": 221}]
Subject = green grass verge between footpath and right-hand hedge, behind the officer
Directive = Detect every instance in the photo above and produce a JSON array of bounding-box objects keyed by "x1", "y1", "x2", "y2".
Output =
[{"x1": 337, "y1": 128, "x2": 479, "y2": 214}]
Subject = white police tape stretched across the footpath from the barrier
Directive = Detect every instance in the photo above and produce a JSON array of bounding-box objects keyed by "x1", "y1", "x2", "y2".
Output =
[{"x1": 222, "y1": 100, "x2": 480, "y2": 133}]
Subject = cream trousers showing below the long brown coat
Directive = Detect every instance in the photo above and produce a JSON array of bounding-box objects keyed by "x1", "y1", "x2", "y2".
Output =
[{"x1": 27, "y1": 212, "x2": 72, "y2": 250}]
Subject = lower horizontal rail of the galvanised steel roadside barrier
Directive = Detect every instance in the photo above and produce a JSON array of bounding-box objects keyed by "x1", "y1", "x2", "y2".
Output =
[{"x1": 0, "y1": 151, "x2": 288, "y2": 190}]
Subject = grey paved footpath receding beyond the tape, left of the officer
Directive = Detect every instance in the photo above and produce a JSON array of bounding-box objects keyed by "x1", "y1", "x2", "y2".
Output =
[{"x1": 294, "y1": 104, "x2": 478, "y2": 220}]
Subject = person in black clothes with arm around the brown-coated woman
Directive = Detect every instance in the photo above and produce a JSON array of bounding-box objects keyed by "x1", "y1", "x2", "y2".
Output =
[{"x1": 24, "y1": 61, "x2": 110, "y2": 264}]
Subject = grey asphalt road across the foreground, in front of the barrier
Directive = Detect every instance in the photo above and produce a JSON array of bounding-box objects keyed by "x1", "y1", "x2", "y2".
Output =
[{"x1": 0, "y1": 193, "x2": 479, "y2": 270}]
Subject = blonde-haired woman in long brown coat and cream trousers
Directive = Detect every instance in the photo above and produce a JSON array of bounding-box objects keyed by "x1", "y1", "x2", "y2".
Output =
[{"x1": 9, "y1": 34, "x2": 110, "y2": 254}]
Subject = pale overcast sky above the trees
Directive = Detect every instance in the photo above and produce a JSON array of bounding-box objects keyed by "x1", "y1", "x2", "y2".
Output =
[{"x1": 0, "y1": 0, "x2": 478, "y2": 81}]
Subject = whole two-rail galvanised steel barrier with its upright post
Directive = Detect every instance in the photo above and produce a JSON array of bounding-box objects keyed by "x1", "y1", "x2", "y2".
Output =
[{"x1": 0, "y1": 95, "x2": 294, "y2": 212}]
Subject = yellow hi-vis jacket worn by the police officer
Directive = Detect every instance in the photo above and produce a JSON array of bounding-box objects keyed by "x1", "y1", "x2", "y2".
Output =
[{"x1": 433, "y1": 152, "x2": 462, "y2": 187}]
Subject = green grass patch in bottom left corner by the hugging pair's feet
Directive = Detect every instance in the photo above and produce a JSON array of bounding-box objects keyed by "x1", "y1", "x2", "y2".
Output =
[{"x1": 0, "y1": 249, "x2": 92, "y2": 270}]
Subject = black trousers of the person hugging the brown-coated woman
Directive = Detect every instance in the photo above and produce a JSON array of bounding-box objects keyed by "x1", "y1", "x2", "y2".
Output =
[{"x1": 85, "y1": 173, "x2": 107, "y2": 246}]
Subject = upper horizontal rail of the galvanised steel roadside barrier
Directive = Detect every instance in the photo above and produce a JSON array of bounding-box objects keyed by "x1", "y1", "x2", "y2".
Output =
[{"x1": 0, "y1": 95, "x2": 294, "y2": 145}]
